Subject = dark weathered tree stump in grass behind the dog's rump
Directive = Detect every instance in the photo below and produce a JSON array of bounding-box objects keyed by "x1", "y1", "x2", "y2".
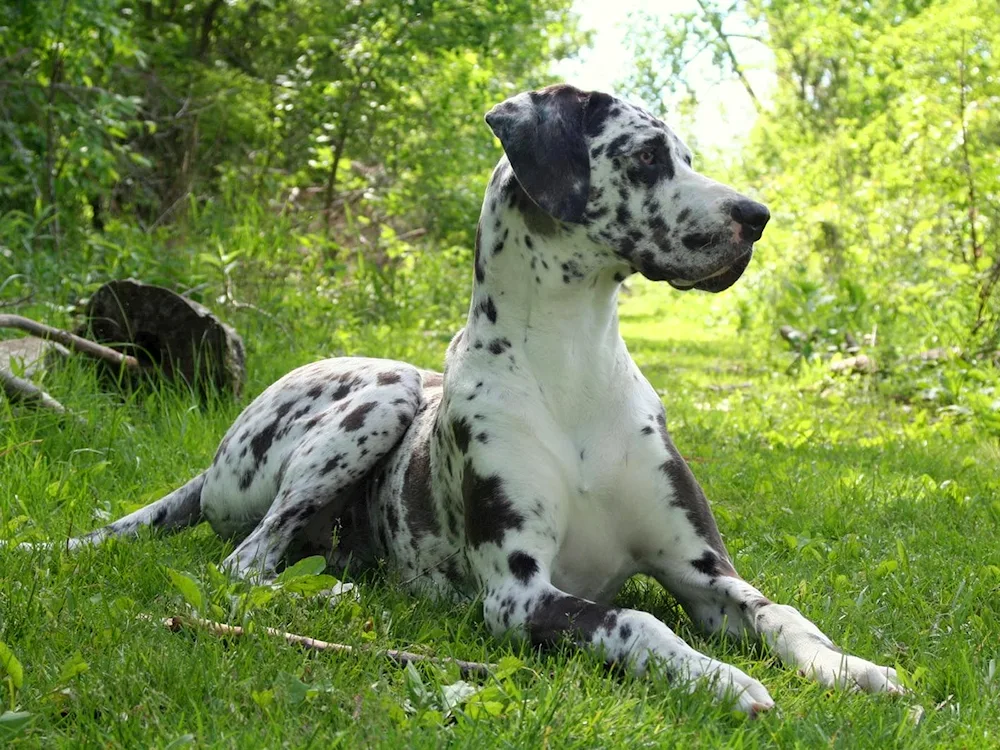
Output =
[{"x1": 79, "y1": 279, "x2": 246, "y2": 395}]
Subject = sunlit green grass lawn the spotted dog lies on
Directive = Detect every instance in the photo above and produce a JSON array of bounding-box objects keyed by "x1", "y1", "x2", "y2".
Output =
[{"x1": 0, "y1": 284, "x2": 1000, "y2": 748}]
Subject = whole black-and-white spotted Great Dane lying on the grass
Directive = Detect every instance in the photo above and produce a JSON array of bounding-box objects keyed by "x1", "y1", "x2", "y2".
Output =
[{"x1": 23, "y1": 85, "x2": 903, "y2": 714}]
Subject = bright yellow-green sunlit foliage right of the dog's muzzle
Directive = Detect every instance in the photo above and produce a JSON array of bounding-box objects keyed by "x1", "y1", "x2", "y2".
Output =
[{"x1": 631, "y1": 0, "x2": 1000, "y2": 438}]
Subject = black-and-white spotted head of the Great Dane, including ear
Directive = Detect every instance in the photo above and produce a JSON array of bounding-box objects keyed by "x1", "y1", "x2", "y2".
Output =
[{"x1": 486, "y1": 85, "x2": 770, "y2": 292}]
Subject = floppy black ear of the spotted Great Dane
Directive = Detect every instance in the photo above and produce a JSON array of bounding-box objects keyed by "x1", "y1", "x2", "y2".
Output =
[{"x1": 486, "y1": 85, "x2": 590, "y2": 223}]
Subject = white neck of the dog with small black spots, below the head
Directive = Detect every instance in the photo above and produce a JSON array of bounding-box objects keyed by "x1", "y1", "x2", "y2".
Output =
[{"x1": 465, "y1": 160, "x2": 628, "y2": 400}]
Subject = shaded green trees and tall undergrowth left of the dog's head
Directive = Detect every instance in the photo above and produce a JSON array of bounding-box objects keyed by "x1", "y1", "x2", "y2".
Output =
[{"x1": 0, "y1": 0, "x2": 583, "y2": 345}]
